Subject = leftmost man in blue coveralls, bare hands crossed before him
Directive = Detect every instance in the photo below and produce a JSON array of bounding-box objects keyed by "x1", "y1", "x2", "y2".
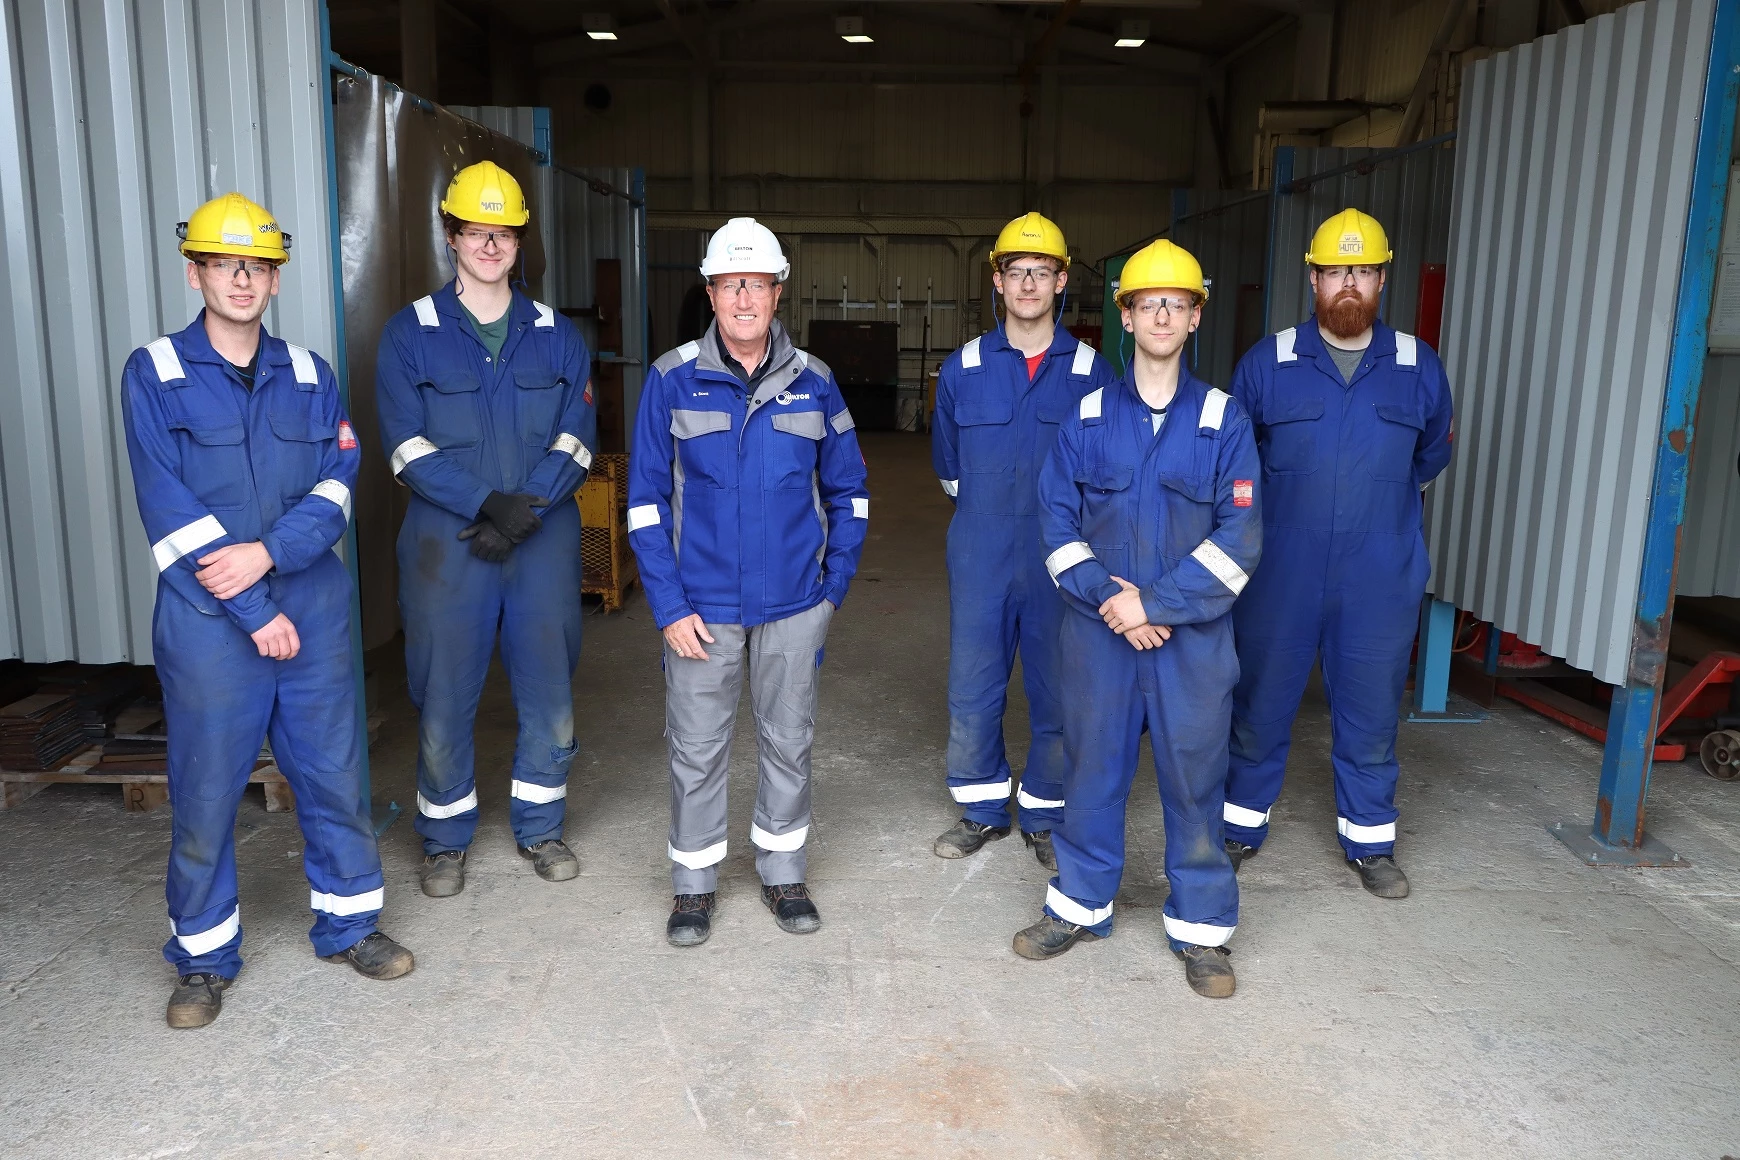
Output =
[{"x1": 122, "y1": 193, "x2": 414, "y2": 1028}]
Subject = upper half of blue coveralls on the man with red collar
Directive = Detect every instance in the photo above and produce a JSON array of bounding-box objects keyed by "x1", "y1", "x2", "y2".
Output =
[{"x1": 931, "y1": 327, "x2": 1117, "y2": 517}]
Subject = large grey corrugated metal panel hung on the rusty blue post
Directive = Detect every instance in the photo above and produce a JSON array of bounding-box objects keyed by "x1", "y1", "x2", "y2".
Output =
[{"x1": 1429, "y1": 0, "x2": 1714, "y2": 683}]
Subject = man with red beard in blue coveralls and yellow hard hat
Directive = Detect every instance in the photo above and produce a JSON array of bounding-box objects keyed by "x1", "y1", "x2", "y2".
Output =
[{"x1": 1225, "y1": 209, "x2": 1451, "y2": 899}]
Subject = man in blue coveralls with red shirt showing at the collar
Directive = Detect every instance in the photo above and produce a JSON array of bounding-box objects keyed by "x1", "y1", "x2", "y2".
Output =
[{"x1": 931, "y1": 214, "x2": 1114, "y2": 870}]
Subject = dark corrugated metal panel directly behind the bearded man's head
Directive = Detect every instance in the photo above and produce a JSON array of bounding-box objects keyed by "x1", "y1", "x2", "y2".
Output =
[{"x1": 1268, "y1": 146, "x2": 1456, "y2": 330}]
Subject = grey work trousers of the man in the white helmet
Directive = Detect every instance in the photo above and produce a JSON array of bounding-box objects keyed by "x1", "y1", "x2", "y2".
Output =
[{"x1": 665, "y1": 600, "x2": 833, "y2": 894}]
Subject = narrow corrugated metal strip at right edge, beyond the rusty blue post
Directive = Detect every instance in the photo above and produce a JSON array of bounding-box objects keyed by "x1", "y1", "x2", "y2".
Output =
[{"x1": 1676, "y1": 356, "x2": 1740, "y2": 597}]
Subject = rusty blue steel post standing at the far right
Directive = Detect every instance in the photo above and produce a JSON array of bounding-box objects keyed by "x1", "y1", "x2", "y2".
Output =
[{"x1": 1590, "y1": 0, "x2": 1740, "y2": 849}]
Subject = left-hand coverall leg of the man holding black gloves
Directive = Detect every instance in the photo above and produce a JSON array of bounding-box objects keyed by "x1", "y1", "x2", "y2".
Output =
[{"x1": 398, "y1": 496, "x2": 497, "y2": 854}]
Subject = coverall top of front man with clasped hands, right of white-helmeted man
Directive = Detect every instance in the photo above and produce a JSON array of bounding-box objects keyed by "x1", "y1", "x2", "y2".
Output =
[{"x1": 1039, "y1": 367, "x2": 1263, "y2": 626}]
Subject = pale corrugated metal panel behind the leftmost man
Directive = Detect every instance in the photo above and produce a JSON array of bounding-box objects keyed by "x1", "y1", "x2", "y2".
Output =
[{"x1": 0, "y1": 0, "x2": 336, "y2": 664}]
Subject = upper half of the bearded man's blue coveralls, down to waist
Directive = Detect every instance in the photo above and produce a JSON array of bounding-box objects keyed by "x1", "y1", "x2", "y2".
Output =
[{"x1": 1232, "y1": 317, "x2": 1451, "y2": 535}]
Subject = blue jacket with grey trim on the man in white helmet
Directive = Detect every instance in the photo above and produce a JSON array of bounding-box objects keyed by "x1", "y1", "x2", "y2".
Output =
[{"x1": 628, "y1": 322, "x2": 870, "y2": 628}]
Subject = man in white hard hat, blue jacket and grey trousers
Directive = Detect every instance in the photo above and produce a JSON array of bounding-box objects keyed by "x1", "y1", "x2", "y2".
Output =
[{"x1": 628, "y1": 217, "x2": 870, "y2": 946}]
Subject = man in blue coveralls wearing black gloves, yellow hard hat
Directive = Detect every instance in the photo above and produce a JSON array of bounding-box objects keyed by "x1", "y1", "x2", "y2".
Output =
[{"x1": 376, "y1": 162, "x2": 597, "y2": 897}]
